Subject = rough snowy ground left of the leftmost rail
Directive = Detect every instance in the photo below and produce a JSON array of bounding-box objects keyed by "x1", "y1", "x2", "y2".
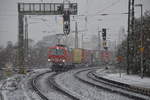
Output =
[{"x1": 0, "y1": 69, "x2": 48, "y2": 100}]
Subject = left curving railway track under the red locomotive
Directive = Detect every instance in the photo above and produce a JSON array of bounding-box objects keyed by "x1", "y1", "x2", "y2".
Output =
[{"x1": 31, "y1": 71, "x2": 80, "y2": 100}]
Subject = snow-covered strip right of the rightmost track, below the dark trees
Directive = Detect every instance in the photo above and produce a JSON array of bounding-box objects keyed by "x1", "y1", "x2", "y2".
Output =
[{"x1": 96, "y1": 69, "x2": 150, "y2": 89}]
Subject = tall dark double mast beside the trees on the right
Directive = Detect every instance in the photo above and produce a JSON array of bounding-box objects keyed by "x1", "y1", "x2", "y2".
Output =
[{"x1": 127, "y1": 0, "x2": 136, "y2": 74}]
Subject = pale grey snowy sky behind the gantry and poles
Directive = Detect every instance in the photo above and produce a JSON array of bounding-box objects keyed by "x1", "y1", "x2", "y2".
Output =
[{"x1": 0, "y1": 0, "x2": 150, "y2": 46}]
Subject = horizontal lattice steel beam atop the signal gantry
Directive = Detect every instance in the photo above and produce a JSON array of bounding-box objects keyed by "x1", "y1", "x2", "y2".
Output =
[{"x1": 18, "y1": 3, "x2": 77, "y2": 15}]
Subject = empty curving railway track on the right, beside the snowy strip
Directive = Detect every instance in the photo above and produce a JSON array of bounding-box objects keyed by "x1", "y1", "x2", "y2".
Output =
[{"x1": 74, "y1": 69, "x2": 150, "y2": 100}]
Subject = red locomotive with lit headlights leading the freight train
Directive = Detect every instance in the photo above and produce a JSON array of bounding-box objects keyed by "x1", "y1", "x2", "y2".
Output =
[{"x1": 48, "y1": 45, "x2": 72, "y2": 71}]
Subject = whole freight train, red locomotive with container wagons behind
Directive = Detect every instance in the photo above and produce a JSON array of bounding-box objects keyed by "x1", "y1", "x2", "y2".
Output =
[{"x1": 48, "y1": 45, "x2": 110, "y2": 72}]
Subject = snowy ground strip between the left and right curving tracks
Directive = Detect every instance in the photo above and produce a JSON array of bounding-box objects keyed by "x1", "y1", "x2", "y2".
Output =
[{"x1": 55, "y1": 70, "x2": 131, "y2": 100}]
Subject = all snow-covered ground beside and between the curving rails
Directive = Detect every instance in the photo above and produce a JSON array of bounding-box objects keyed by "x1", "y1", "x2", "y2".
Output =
[{"x1": 0, "y1": 66, "x2": 150, "y2": 100}]
